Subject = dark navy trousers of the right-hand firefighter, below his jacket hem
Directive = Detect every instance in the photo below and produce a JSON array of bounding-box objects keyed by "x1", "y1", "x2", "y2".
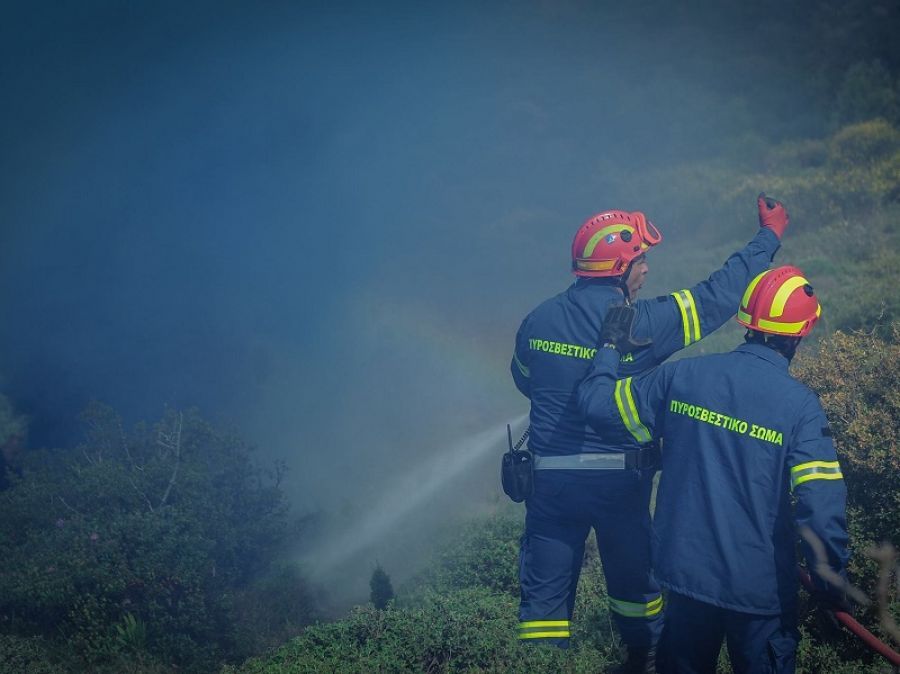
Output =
[{"x1": 656, "y1": 592, "x2": 799, "y2": 674}]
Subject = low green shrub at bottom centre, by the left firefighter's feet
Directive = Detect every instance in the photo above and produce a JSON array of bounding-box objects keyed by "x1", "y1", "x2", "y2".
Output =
[{"x1": 226, "y1": 588, "x2": 614, "y2": 674}]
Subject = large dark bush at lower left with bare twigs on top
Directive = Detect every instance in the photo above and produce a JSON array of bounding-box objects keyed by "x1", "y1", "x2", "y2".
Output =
[{"x1": 0, "y1": 406, "x2": 309, "y2": 671}]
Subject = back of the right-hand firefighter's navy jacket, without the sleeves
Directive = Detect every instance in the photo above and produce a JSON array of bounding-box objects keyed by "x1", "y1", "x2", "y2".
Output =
[{"x1": 655, "y1": 344, "x2": 814, "y2": 613}]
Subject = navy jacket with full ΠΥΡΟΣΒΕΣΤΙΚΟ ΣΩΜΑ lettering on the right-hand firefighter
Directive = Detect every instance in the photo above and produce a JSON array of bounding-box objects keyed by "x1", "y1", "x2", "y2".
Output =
[{"x1": 578, "y1": 344, "x2": 848, "y2": 615}]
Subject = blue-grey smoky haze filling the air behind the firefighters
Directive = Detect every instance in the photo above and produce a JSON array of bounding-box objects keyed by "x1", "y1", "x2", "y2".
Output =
[{"x1": 0, "y1": 0, "x2": 824, "y2": 600}]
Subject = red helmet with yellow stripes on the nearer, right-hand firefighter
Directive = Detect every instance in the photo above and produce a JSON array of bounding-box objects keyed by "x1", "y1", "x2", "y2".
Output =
[{"x1": 737, "y1": 266, "x2": 822, "y2": 337}]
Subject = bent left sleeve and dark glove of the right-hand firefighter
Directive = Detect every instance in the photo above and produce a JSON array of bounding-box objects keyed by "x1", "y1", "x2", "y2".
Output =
[{"x1": 576, "y1": 347, "x2": 677, "y2": 448}]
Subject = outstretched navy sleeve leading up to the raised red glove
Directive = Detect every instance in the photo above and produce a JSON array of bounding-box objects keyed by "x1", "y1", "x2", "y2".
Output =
[{"x1": 634, "y1": 228, "x2": 781, "y2": 364}]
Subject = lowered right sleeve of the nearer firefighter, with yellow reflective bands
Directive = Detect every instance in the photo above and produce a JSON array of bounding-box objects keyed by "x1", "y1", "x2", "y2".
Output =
[{"x1": 787, "y1": 392, "x2": 849, "y2": 591}]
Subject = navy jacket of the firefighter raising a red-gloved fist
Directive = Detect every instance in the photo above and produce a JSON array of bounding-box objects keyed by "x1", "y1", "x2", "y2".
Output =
[{"x1": 510, "y1": 229, "x2": 780, "y2": 456}]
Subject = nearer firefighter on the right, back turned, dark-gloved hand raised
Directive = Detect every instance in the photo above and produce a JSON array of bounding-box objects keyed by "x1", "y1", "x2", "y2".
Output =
[{"x1": 578, "y1": 266, "x2": 848, "y2": 674}]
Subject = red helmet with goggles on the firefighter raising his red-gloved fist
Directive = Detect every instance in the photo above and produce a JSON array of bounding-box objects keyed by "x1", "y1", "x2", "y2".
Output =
[{"x1": 572, "y1": 211, "x2": 662, "y2": 276}]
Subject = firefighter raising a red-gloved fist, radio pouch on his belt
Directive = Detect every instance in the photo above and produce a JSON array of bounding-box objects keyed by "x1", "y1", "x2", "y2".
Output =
[{"x1": 510, "y1": 195, "x2": 788, "y2": 672}]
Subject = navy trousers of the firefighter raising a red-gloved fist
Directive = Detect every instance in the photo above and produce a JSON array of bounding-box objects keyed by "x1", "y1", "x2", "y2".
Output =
[{"x1": 519, "y1": 470, "x2": 663, "y2": 648}]
